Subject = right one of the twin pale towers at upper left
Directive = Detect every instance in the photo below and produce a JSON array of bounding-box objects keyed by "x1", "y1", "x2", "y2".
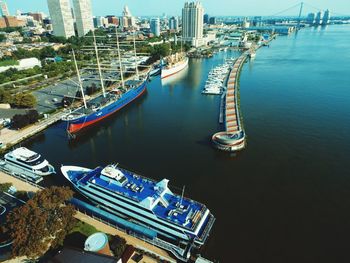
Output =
[{"x1": 73, "y1": 0, "x2": 94, "y2": 37}]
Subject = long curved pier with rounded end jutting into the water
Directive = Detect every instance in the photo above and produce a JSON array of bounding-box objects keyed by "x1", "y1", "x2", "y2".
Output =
[{"x1": 212, "y1": 54, "x2": 247, "y2": 152}]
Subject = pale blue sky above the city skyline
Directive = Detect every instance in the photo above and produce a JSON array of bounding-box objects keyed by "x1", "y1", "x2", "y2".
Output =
[{"x1": 5, "y1": 0, "x2": 350, "y2": 16}]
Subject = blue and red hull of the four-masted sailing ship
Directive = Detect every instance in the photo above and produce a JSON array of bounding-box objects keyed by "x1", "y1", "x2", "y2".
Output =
[{"x1": 68, "y1": 78, "x2": 148, "y2": 133}]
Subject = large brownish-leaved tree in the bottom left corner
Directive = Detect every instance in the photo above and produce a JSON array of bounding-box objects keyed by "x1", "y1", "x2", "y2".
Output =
[{"x1": 1, "y1": 186, "x2": 76, "y2": 258}]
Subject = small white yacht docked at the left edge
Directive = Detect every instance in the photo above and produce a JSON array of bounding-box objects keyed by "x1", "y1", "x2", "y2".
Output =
[{"x1": 3, "y1": 147, "x2": 55, "y2": 176}]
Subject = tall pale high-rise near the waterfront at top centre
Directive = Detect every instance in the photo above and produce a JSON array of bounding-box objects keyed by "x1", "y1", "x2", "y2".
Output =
[{"x1": 182, "y1": 2, "x2": 204, "y2": 47}]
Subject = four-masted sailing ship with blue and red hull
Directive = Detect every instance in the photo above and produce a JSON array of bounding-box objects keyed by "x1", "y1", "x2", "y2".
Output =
[{"x1": 62, "y1": 30, "x2": 149, "y2": 134}]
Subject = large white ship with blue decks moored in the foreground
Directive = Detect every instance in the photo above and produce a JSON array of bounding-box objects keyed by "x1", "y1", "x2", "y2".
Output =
[{"x1": 61, "y1": 165, "x2": 215, "y2": 247}]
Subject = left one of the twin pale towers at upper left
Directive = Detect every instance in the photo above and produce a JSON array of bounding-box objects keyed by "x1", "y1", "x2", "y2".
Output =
[{"x1": 47, "y1": 0, "x2": 75, "y2": 38}]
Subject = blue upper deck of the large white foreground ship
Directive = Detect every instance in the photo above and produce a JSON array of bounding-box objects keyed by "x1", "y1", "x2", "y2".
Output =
[{"x1": 68, "y1": 167, "x2": 206, "y2": 229}]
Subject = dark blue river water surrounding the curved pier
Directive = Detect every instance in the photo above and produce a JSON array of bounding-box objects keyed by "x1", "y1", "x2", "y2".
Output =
[{"x1": 25, "y1": 26, "x2": 350, "y2": 263}]
